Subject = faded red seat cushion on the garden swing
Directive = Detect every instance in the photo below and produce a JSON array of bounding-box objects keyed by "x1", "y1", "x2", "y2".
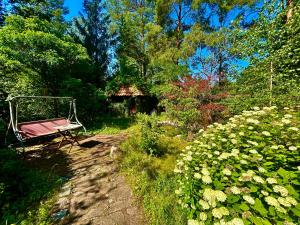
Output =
[{"x1": 18, "y1": 118, "x2": 70, "y2": 139}]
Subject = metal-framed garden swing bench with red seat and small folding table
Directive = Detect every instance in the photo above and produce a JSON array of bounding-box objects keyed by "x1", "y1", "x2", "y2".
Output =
[{"x1": 7, "y1": 96, "x2": 86, "y2": 153}]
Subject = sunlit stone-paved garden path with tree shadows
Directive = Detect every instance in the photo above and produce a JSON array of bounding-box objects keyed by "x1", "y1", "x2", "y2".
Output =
[{"x1": 50, "y1": 135, "x2": 146, "y2": 225}]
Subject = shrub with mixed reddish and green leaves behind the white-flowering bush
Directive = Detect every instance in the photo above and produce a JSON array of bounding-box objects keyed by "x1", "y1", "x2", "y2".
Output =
[{"x1": 161, "y1": 76, "x2": 224, "y2": 132}]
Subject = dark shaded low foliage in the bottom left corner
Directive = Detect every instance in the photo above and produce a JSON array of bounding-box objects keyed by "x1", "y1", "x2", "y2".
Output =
[{"x1": 0, "y1": 149, "x2": 61, "y2": 224}]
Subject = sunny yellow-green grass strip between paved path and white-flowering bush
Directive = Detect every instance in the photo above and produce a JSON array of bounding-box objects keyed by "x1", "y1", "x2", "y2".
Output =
[{"x1": 121, "y1": 129, "x2": 187, "y2": 225}]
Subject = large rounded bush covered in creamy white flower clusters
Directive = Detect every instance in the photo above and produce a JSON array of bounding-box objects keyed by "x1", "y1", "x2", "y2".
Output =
[{"x1": 174, "y1": 107, "x2": 300, "y2": 225}]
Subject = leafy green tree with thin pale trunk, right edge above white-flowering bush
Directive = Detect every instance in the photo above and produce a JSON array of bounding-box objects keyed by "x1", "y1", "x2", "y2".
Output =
[{"x1": 228, "y1": 1, "x2": 300, "y2": 113}]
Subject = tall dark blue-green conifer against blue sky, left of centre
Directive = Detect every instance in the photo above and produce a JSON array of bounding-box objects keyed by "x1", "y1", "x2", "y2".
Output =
[{"x1": 72, "y1": 0, "x2": 114, "y2": 87}]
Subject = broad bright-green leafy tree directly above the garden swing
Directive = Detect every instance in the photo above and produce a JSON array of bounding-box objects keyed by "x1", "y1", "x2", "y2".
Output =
[{"x1": 0, "y1": 16, "x2": 89, "y2": 94}]
